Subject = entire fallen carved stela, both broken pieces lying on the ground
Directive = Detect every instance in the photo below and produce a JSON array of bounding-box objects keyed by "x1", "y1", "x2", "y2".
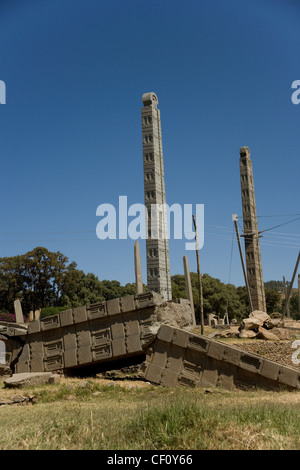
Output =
[{"x1": 0, "y1": 292, "x2": 300, "y2": 390}]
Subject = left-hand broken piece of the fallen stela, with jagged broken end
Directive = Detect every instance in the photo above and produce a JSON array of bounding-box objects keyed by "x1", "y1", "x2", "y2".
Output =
[{"x1": 0, "y1": 292, "x2": 192, "y2": 373}]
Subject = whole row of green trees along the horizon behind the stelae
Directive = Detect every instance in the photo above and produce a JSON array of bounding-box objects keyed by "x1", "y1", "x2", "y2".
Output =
[{"x1": 0, "y1": 247, "x2": 299, "y2": 321}]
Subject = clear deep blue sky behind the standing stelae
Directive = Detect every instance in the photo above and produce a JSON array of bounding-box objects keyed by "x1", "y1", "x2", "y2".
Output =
[{"x1": 0, "y1": 0, "x2": 300, "y2": 285}]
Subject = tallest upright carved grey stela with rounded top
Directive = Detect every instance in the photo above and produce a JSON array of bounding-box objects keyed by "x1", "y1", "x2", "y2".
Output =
[{"x1": 142, "y1": 92, "x2": 172, "y2": 300}]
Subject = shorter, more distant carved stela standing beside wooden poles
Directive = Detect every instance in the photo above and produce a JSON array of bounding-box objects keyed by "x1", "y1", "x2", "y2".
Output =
[{"x1": 240, "y1": 147, "x2": 266, "y2": 312}]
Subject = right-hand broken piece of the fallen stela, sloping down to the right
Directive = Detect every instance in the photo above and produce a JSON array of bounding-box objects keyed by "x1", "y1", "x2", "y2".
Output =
[{"x1": 143, "y1": 325, "x2": 300, "y2": 391}]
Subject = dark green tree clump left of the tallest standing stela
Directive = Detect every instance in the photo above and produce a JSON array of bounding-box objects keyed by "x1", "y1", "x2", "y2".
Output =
[{"x1": 0, "y1": 247, "x2": 135, "y2": 320}]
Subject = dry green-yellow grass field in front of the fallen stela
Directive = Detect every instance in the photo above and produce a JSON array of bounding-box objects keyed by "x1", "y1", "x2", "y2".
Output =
[{"x1": 0, "y1": 378, "x2": 300, "y2": 450}]
